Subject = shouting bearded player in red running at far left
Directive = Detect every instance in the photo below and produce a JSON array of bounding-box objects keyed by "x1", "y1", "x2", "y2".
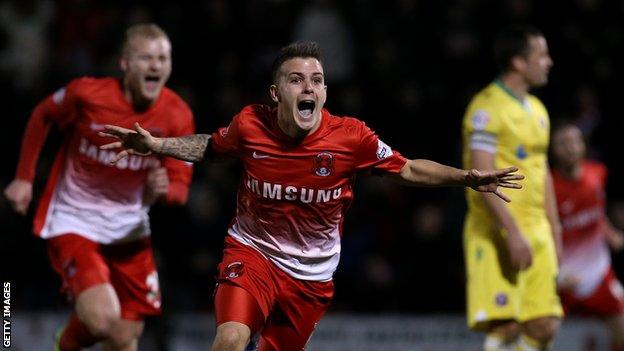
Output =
[{"x1": 5, "y1": 24, "x2": 194, "y2": 351}]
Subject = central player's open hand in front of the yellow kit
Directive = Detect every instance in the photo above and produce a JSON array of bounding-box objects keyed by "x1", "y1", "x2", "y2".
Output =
[{"x1": 466, "y1": 167, "x2": 524, "y2": 202}]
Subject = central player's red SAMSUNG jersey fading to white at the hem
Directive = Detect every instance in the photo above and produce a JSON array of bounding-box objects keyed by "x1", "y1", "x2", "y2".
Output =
[{"x1": 212, "y1": 105, "x2": 407, "y2": 281}]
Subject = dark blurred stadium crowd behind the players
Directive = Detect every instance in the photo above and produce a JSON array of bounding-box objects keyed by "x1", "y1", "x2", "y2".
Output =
[{"x1": 0, "y1": 0, "x2": 624, "y2": 350}]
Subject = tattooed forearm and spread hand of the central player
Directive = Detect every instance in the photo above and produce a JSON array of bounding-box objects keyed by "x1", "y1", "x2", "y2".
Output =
[{"x1": 100, "y1": 123, "x2": 210, "y2": 163}]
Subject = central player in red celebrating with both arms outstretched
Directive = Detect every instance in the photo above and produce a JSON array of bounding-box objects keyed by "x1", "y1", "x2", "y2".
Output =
[{"x1": 102, "y1": 43, "x2": 523, "y2": 350}]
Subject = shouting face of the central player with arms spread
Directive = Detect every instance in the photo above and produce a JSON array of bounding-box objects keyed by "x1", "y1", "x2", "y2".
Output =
[{"x1": 270, "y1": 58, "x2": 327, "y2": 137}]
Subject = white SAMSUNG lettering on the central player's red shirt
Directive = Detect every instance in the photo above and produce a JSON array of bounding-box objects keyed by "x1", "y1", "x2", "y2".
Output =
[{"x1": 245, "y1": 177, "x2": 342, "y2": 204}]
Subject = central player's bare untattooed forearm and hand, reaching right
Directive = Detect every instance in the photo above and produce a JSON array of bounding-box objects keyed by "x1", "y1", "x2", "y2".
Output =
[{"x1": 393, "y1": 159, "x2": 524, "y2": 202}]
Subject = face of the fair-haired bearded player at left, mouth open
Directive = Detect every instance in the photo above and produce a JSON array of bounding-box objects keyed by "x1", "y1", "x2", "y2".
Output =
[{"x1": 121, "y1": 36, "x2": 171, "y2": 102}]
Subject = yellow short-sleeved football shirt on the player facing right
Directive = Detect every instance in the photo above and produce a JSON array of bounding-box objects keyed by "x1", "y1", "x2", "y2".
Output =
[{"x1": 462, "y1": 80, "x2": 550, "y2": 222}]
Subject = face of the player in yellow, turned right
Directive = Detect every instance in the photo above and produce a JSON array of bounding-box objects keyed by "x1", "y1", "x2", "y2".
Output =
[{"x1": 522, "y1": 36, "x2": 553, "y2": 87}]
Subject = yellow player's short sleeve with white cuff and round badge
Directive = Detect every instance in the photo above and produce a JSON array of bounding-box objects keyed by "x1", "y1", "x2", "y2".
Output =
[{"x1": 464, "y1": 106, "x2": 501, "y2": 154}]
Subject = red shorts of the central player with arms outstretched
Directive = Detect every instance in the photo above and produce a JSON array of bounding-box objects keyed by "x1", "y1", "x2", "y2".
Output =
[{"x1": 215, "y1": 235, "x2": 334, "y2": 351}]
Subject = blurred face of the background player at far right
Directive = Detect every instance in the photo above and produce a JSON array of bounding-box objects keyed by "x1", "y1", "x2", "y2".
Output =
[{"x1": 552, "y1": 126, "x2": 585, "y2": 167}]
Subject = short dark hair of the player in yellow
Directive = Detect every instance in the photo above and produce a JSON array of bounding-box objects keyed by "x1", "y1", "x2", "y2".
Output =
[{"x1": 494, "y1": 25, "x2": 544, "y2": 73}]
